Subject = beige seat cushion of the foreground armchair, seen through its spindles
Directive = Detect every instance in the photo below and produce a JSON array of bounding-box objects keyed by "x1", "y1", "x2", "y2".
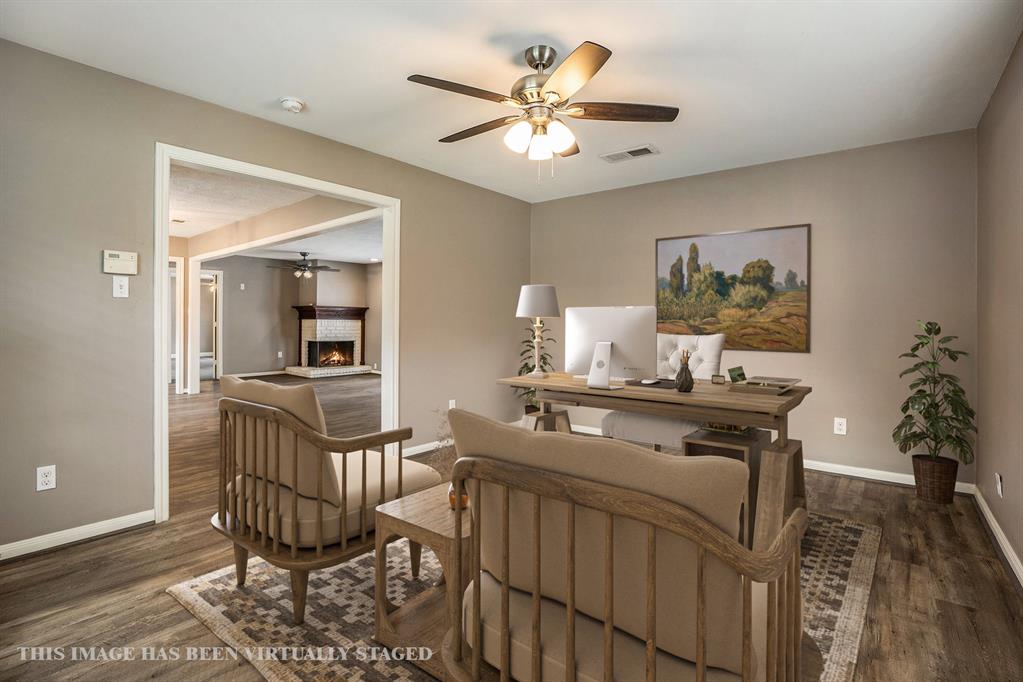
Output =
[{"x1": 462, "y1": 573, "x2": 767, "y2": 682}]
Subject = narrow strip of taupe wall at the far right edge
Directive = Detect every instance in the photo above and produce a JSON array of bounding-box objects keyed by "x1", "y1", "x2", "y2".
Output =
[{"x1": 977, "y1": 33, "x2": 1023, "y2": 555}]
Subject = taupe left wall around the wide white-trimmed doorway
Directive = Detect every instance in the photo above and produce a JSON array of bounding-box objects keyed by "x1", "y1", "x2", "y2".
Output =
[{"x1": 0, "y1": 41, "x2": 529, "y2": 544}]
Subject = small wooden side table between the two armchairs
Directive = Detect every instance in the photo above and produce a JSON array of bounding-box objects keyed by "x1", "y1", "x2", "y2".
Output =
[{"x1": 373, "y1": 483, "x2": 472, "y2": 680}]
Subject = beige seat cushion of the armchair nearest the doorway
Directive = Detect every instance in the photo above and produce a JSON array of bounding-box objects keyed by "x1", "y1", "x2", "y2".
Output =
[{"x1": 228, "y1": 450, "x2": 441, "y2": 547}]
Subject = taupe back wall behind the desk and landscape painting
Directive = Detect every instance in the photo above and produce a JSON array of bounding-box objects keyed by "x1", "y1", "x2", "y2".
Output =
[{"x1": 531, "y1": 131, "x2": 977, "y2": 481}]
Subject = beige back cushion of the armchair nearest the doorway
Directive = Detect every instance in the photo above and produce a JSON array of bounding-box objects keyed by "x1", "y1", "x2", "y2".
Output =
[{"x1": 220, "y1": 376, "x2": 341, "y2": 506}]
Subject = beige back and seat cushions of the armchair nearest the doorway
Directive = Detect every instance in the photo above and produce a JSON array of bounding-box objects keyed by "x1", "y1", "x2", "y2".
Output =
[{"x1": 221, "y1": 376, "x2": 441, "y2": 547}]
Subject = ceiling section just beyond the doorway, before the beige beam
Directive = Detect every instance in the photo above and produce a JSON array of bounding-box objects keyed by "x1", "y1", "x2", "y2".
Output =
[{"x1": 170, "y1": 165, "x2": 313, "y2": 237}]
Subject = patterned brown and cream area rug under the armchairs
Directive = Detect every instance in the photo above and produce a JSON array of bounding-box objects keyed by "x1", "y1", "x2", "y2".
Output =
[{"x1": 167, "y1": 513, "x2": 881, "y2": 682}]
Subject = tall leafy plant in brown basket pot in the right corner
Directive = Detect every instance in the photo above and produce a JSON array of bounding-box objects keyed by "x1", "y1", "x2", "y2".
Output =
[{"x1": 892, "y1": 321, "x2": 977, "y2": 504}]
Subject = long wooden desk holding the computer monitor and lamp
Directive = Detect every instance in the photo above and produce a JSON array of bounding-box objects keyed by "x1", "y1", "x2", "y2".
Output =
[{"x1": 497, "y1": 372, "x2": 812, "y2": 550}]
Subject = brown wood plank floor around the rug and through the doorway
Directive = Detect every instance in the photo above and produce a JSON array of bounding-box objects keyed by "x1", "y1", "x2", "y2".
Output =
[{"x1": 0, "y1": 376, "x2": 1023, "y2": 682}]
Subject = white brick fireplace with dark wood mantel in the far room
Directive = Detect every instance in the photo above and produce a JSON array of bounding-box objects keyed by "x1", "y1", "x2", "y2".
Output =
[{"x1": 284, "y1": 306, "x2": 372, "y2": 378}]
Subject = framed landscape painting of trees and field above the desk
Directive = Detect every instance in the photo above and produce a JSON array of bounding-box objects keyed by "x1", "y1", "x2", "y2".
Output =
[{"x1": 657, "y1": 225, "x2": 810, "y2": 353}]
